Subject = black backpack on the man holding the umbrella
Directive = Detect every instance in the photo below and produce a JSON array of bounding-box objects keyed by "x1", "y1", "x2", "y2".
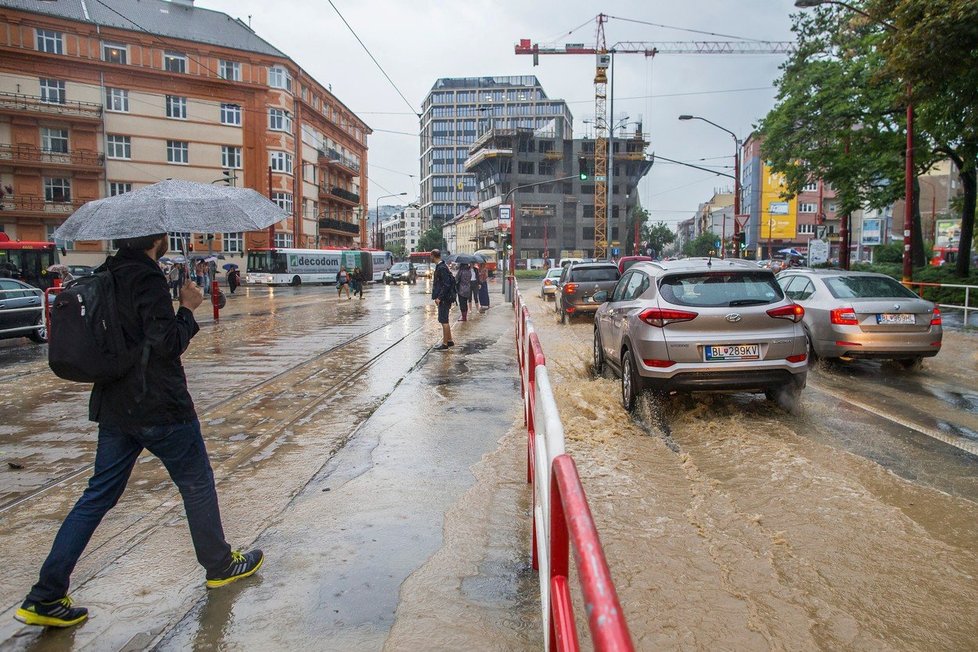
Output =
[{"x1": 48, "y1": 265, "x2": 149, "y2": 383}]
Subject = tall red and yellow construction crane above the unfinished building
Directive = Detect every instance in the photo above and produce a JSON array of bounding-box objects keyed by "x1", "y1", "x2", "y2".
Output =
[{"x1": 516, "y1": 14, "x2": 795, "y2": 258}]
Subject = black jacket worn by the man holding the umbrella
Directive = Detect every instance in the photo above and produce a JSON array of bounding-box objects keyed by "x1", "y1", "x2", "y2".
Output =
[{"x1": 88, "y1": 249, "x2": 200, "y2": 427}]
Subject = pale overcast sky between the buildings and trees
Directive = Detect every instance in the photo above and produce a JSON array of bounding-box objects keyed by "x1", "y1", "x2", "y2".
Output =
[{"x1": 204, "y1": 0, "x2": 797, "y2": 223}]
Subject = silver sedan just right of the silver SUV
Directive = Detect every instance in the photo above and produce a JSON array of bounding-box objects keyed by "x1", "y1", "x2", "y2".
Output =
[{"x1": 778, "y1": 269, "x2": 943, "y2": 369}]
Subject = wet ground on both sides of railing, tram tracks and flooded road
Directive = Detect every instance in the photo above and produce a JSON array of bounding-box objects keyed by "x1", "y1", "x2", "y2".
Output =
[{"x1": 0, "y1": 285, "x2": 978, "y2": 650}]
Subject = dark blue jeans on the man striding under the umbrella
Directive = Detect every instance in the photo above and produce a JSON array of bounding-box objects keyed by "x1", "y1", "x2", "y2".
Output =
[{"x1": 27, "y1": 420, "x2": 231, "y2": 602}]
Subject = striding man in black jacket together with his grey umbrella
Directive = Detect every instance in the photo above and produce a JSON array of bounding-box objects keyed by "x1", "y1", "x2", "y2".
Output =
[{"x1": 14, "y1": 181, "x2": 285, "y2": 627}]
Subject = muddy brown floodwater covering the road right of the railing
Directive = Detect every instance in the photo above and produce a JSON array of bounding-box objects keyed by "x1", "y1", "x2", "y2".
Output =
[{"x1": 528, "y1": 293, "x2": 978, "y2": 650}]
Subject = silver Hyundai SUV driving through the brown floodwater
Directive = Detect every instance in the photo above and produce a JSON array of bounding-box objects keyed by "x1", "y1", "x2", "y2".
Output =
[{"x1": 594, "y1": 258, "x2": 808, "y2": 411}]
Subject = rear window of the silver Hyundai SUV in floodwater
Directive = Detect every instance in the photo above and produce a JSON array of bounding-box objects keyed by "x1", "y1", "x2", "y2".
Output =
[{"x1": 659, "y1": 271, "x2": 784, "y2": 308}]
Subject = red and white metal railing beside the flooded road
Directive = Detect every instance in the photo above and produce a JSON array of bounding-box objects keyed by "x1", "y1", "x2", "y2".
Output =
[{"x1": 513, "y1": 278, "x2": 634, "y2": 652}]
